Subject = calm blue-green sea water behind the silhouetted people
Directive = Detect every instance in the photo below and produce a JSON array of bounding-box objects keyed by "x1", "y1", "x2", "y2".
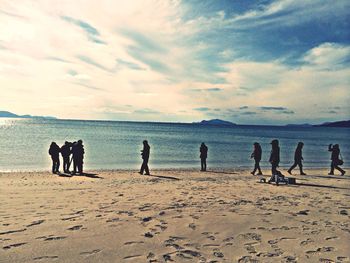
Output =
[{"x1": 0, "y1": 118, "x2": 350, "y2": 171}]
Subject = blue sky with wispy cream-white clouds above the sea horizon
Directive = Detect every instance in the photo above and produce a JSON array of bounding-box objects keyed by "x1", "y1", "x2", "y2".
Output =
[{"x1": 0, "y1": 0, "x2": 350, "y2": 124}]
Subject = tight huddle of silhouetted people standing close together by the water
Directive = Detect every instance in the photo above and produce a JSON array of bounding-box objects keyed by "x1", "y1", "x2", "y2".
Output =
[{"x1": 49, "y1": 140, "x2": 85, "y2": 175}]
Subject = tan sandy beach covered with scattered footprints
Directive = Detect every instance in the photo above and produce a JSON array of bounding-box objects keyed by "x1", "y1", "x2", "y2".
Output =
[{"x1": 0, "y1": 169, "x2": 350, "y2": 263}]
